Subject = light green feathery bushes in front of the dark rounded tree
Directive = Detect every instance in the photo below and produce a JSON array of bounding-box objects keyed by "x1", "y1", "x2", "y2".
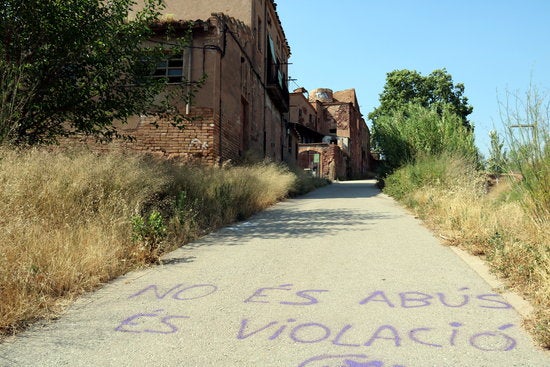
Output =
[{"x1": 373, "y1": 103, "x2": 478, "y2": 174}]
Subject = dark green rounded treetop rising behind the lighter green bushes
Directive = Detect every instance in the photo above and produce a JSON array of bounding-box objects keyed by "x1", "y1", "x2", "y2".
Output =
[{"x1": 369, "y1": 69, "x2": 473, "y2": 128}]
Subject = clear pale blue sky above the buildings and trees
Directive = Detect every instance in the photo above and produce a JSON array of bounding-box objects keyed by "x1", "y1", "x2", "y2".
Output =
[{"x1": 276, "y1": 0, "x2": 550, "y2": 155}]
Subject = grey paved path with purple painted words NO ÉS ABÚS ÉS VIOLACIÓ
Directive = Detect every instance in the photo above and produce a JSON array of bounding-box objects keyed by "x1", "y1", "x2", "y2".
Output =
[{"x1": 0, "y1": 181, "x2": 550, "y2": 367}]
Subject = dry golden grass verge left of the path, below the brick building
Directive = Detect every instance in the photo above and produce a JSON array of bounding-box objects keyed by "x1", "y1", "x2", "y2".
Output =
[{"x1": 0, "y1": 148, "x2": 326, "y2": 335}]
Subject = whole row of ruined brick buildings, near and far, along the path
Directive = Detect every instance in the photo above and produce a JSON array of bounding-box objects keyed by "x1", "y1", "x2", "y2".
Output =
[{"x1": 95, "y1": 0, "x2": 376, "y2": 179}]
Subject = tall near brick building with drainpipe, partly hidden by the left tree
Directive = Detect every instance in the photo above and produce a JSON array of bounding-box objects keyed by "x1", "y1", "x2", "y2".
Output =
[{"x1": 117, "y1": 0, "x2": 296, "y2": 164}]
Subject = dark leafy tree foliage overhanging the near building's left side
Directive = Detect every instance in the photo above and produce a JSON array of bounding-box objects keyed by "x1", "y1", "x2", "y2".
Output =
[{"x1": 0, "y1": 0, "x2": 199, "y2": 144}]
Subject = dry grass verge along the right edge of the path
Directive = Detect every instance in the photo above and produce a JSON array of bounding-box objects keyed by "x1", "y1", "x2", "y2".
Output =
[{"x1": 384, "y1": 155, "x2": 550, "y2": 348}]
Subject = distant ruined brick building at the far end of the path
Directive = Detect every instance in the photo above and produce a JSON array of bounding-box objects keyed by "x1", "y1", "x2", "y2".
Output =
[{"x1": 289, "y1": 88, "x2": 372, "y2": 179}]
